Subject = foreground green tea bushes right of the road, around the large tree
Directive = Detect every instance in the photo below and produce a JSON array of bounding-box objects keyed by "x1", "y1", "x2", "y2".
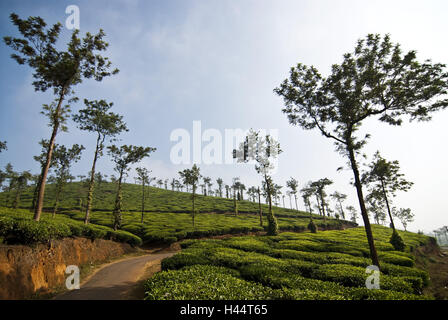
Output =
[{"x1": 145, "y1": 226, "x2": 436, "y2": 300}]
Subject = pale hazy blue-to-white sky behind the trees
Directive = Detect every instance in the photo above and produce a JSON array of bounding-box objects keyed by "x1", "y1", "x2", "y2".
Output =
[{"x1": 0, "y1": 0, "x2": 448, "y2": 231}]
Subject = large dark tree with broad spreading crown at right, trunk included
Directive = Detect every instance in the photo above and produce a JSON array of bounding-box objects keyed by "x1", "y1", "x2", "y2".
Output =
[{"x1": 274, "y1": 34, "x2": 448, "y2": 266}]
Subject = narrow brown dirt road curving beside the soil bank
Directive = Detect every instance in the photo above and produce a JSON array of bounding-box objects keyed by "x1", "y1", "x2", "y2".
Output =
[{"x1": 54, "y1": 252, "x2": 176, "y2": 300}]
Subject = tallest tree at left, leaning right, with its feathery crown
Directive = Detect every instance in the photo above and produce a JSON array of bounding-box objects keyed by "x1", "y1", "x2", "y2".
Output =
[{"x1": 3, "y1": 13, "x2": 118, "y2": 221}]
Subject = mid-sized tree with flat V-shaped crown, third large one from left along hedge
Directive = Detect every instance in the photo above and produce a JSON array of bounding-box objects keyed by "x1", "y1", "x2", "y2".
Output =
[{"x1": 107, "y1": 145, "x2": 156, "y2": 230}]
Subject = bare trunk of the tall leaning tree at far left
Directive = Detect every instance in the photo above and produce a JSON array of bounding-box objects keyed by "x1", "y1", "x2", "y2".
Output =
[{"x1": 34, "y1": 87, "x2": 66, "y2": 221}]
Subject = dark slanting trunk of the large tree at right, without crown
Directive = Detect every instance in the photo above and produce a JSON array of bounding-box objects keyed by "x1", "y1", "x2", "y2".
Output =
[{"x1": 347, "y1": 146, "x2": 380, "y2": 268}]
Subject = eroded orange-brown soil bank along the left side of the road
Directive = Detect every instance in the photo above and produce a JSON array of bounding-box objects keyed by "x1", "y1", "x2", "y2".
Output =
[{"x1": 0, "y1": 238, "x2": 136, "y2": 299}]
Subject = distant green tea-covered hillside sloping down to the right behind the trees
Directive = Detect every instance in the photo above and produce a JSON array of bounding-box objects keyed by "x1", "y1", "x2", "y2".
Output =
[{"x1": 0, "y1": 182, "x2": 354, "y2": 243}]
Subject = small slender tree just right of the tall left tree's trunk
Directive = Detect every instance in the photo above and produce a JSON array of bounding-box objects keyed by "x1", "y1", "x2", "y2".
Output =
[{"x1": 53, "y1": 144, "x2": 84, "y2": 217}]
